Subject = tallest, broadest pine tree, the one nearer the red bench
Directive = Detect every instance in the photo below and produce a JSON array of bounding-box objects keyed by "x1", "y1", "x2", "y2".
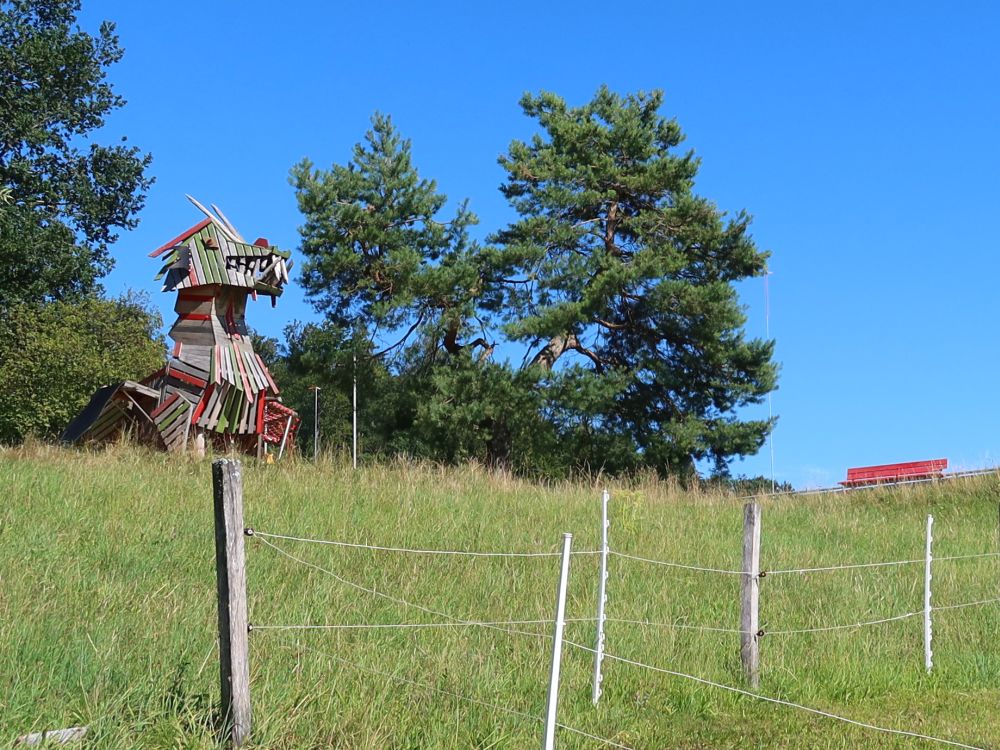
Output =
[{"x1": 492, "y1": 88, "x2": 776, "y2": 474}]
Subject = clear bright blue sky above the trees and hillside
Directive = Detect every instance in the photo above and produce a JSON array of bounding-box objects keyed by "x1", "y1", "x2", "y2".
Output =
[{"x1": 82, "y1": 0, "x2": 1000, "y2": 486}]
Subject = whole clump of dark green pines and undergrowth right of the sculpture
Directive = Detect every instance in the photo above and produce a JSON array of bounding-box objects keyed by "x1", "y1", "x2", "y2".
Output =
[{"x1": 286, "y1": 89, "x2": 776, "y2": 478}]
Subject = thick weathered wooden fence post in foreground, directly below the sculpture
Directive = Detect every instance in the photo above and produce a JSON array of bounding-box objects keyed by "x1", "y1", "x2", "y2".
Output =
[{"x1": 212, "y1": 459, "x2": 250, "y2": 747}]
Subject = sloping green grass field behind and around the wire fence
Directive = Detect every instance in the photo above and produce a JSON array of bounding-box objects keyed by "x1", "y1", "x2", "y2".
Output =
[{"x1": 0, "y1": 447, "x2": 1000, "y2": 750}]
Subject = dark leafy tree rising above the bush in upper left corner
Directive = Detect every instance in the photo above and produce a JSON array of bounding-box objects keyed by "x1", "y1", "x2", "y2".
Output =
[{"x1": 0, "y1": 0, "x2": 152, "y2": 308}]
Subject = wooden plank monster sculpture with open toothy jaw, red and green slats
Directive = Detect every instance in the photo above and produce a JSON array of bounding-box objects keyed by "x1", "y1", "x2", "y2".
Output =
[{"x1": 63, "y1": 196, "x2": 299, "y2": 455}]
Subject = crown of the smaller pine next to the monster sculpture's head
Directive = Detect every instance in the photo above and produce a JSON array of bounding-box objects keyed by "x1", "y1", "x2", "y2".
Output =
[{"x1": 291, "y1": 113, "x2": 488, "y2": 366}]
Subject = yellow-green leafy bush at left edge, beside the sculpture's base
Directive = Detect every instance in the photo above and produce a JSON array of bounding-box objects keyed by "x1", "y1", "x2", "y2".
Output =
[{"x1": 0, "y1": 295, "x2": 166, "y2": 443}]
